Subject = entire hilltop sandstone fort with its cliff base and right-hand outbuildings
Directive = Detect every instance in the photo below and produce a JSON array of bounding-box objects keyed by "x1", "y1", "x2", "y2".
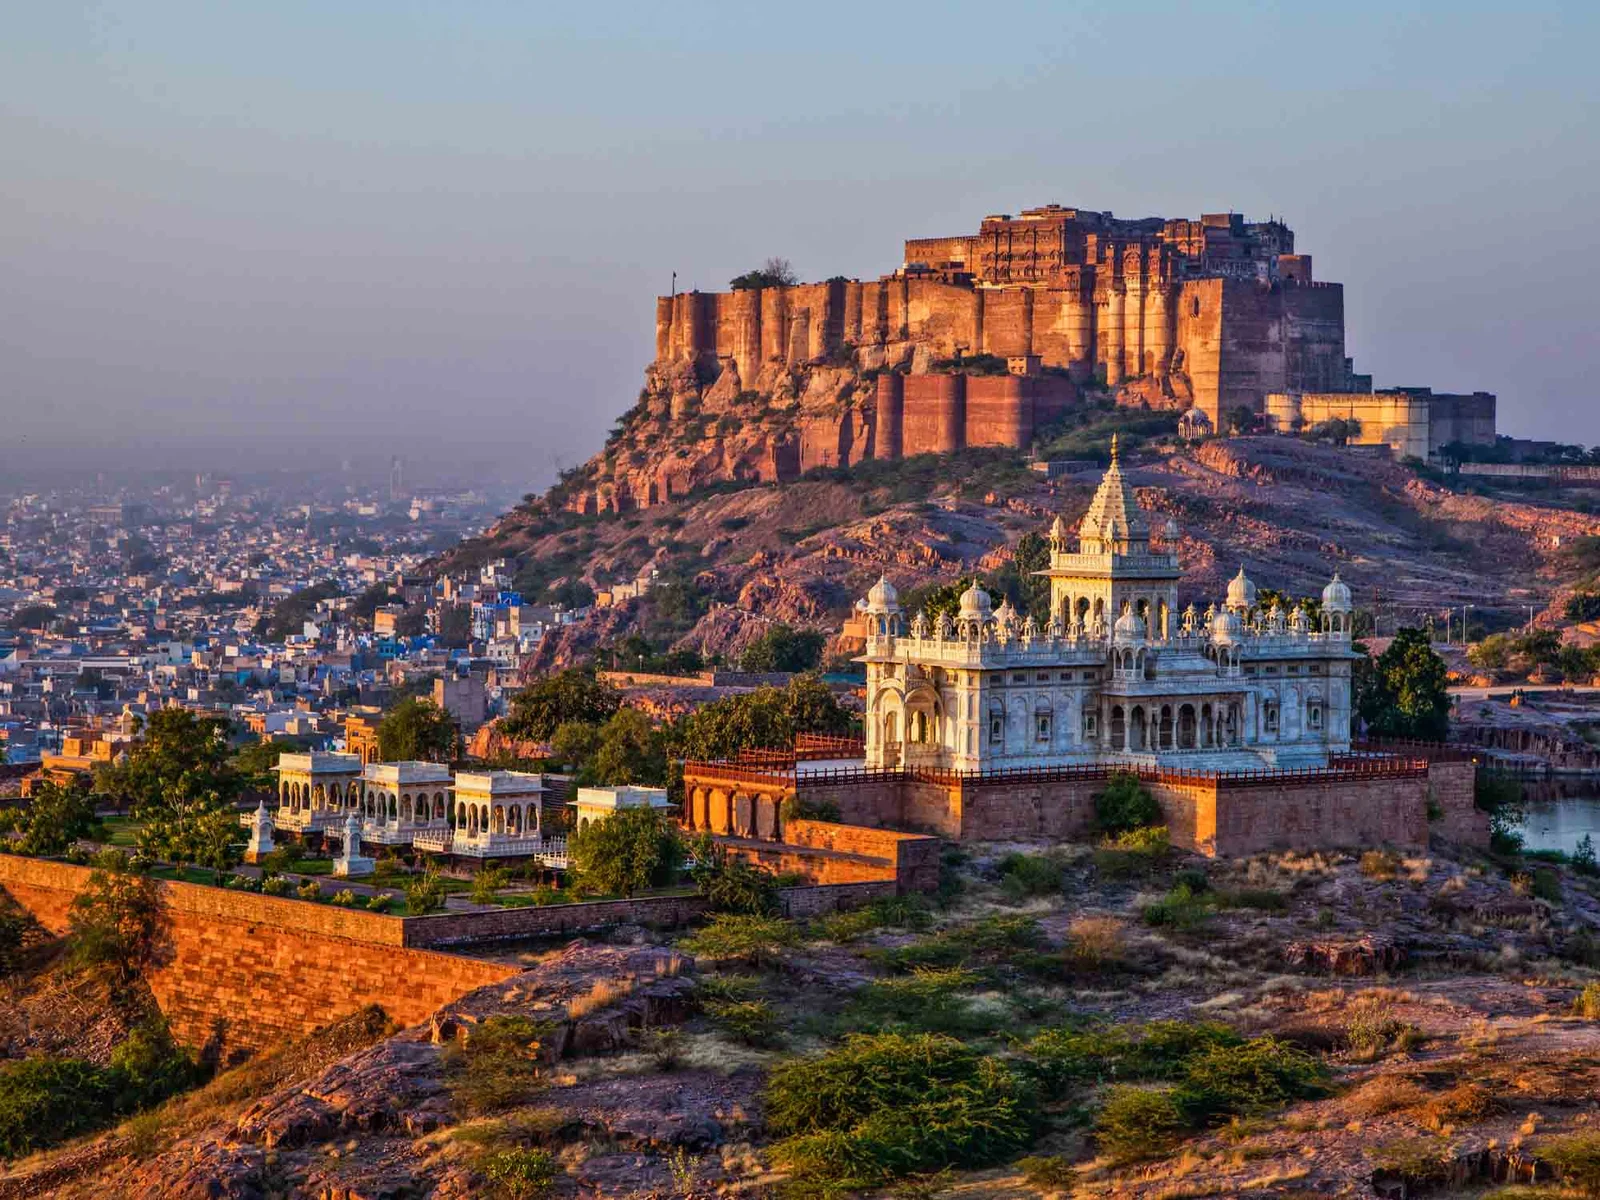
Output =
[{"x1": 562, "y1": 205, "x2": 1494, "y2": 512}]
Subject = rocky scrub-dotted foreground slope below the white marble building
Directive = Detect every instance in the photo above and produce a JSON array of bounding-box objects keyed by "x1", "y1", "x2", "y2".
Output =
[{"x1": 15, "y1": 845, "x2": 1600, "y2": 1200}]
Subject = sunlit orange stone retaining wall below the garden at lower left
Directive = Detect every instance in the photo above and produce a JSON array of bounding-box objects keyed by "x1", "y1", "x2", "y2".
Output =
[{"x1": 0, "y1": 854, "x2": 520, "y2": 1059}]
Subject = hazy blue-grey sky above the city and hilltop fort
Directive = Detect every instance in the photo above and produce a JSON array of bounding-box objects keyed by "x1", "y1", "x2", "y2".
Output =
[{"x1": 0, "y1": 0, "x2": 1600, "y2": 486}]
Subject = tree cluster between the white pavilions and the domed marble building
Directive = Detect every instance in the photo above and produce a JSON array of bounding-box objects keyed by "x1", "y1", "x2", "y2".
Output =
[{"x1": 501, "y1": 667, "x2": 854, "y2": 787}]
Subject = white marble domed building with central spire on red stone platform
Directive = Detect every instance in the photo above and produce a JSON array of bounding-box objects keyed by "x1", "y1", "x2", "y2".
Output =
[{"x1": 858, "y1": 445, "x2": 1357, "y2": 771}]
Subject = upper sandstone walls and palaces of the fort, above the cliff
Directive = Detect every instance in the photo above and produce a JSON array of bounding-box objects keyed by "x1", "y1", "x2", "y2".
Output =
[{"x1": 656, "y1": 206, "x2": 1349, "y2": 419}]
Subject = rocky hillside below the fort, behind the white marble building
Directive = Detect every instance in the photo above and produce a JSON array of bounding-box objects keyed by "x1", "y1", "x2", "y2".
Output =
[{"x1": 438, "y1": 437, "x2": 1600, "y2": 669}]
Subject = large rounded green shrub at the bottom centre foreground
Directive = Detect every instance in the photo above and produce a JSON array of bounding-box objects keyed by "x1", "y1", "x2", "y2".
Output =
[{"x1": 765, "y1": 1034, "x2": 1038, "y2": 1190}]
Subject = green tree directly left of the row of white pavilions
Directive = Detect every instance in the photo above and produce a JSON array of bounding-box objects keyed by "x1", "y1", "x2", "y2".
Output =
[{"x1": 98, "y1": 709, "x2": 245, "y2": 862}]
